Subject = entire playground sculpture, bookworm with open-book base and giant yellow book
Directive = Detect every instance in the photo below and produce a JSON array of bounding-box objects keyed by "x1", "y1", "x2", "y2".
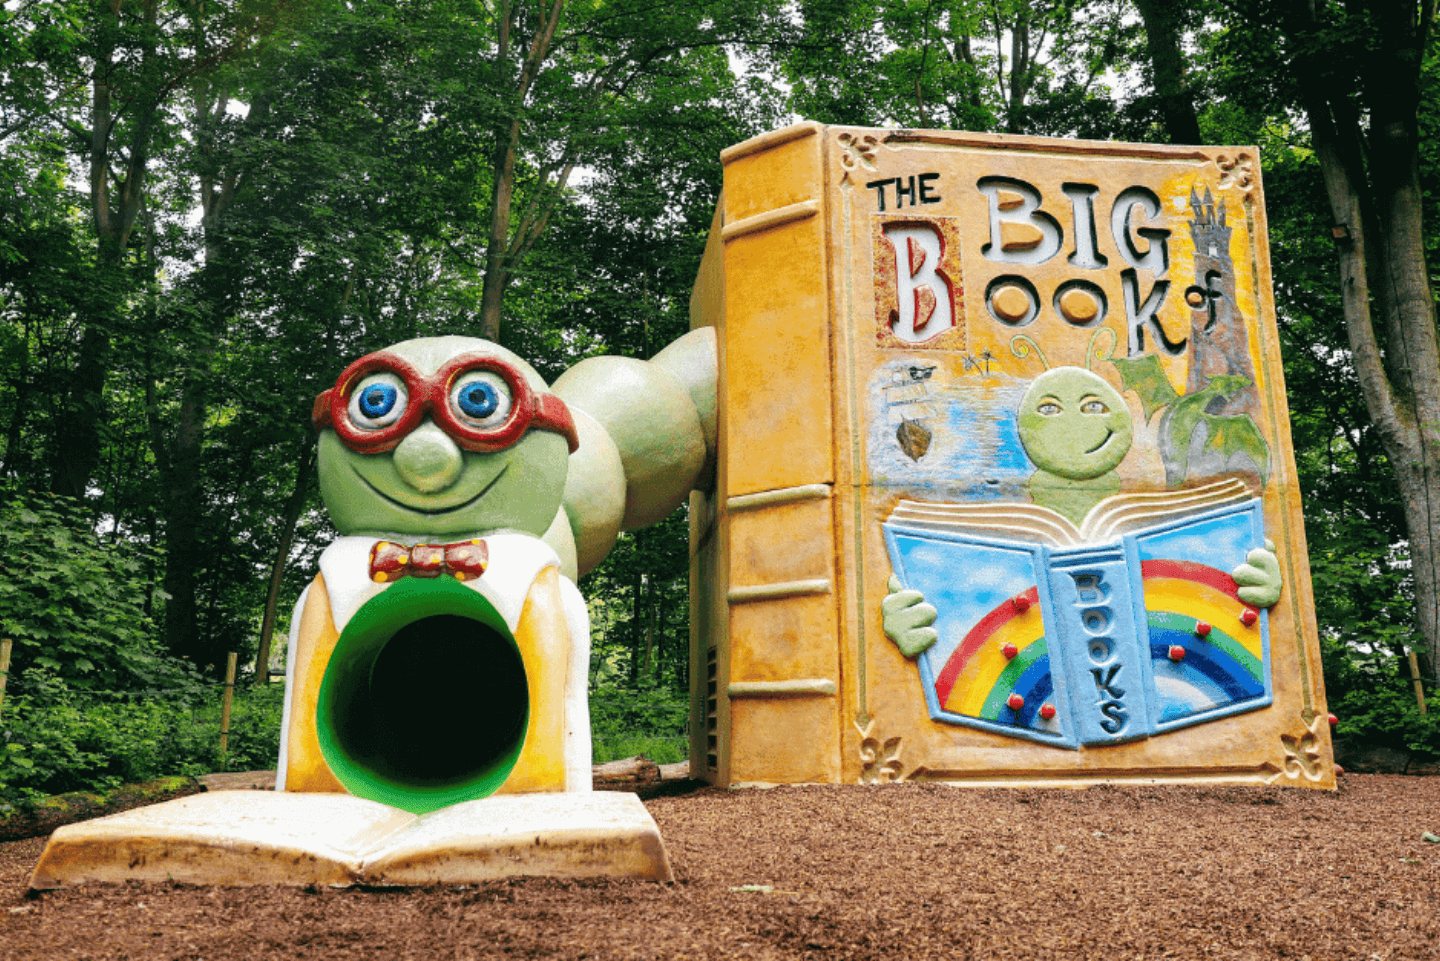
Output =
[{"x1": 33, "y1": 124, "x2": 1335, "y2": 886}]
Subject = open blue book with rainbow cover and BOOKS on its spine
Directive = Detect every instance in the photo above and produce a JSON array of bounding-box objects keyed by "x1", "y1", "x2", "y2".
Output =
[{"x1": 884, "y1": 480, "x2": 1272, "y2": 748}]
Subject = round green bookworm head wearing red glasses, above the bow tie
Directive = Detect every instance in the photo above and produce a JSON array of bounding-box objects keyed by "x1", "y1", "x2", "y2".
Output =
[{"x1": 314, "y1": 337, "x2": 577, "y2": 536}]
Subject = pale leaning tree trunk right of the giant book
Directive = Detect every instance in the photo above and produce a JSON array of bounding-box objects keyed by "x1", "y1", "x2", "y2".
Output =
[{"x1": 1286, "y1": 0, "x2": 1440, "y2": 683}]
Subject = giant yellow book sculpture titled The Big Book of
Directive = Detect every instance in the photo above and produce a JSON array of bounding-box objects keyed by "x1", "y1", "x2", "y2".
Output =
[{"x1": 691, "y1": 122, "x2": 1335, "y2": 788}]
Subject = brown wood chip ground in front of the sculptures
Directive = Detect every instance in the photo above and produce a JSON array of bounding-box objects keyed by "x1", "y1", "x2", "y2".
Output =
[{"x1": 0, "y1": 775, "x2": 1440, "y2": 961}]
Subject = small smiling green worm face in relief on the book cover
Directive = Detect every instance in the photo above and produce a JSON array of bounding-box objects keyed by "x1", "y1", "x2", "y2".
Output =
[{"x1": 1020, "y1": 367, "x2": 1135, "y2": 480}]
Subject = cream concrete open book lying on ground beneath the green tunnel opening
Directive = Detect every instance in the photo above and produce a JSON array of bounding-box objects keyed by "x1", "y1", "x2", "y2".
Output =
[{"x1": 30, "y1": 791, "x2": 674, "y2": 890}]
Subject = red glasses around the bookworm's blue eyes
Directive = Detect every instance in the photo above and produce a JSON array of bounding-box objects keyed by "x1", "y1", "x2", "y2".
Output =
[{"x1": 310, "y1": 350, "x2": 580, "y2": 454}]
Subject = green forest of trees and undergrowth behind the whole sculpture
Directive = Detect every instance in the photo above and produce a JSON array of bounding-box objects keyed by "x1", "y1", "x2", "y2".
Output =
[{"x1": 0, "y1": 0, "x2": 1440, "y2": 804}]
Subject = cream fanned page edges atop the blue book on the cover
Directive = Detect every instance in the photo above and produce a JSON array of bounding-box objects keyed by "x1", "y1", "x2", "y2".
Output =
[{"x1": 887, "y1": 478, "x2": 1251, "y2": 547}]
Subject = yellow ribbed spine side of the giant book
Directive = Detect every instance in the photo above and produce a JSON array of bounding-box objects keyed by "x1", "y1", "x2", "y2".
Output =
[{"x1": 691, "y1": 122, "x2": 840, "y2": 784}]
